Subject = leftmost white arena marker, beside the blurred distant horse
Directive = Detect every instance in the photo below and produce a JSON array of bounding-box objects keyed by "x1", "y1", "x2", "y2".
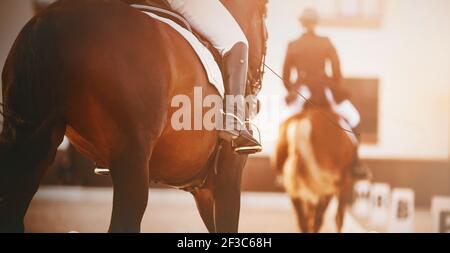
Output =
[{"x1": 352, "y1": 180, "x2": 371, "y2": 219}]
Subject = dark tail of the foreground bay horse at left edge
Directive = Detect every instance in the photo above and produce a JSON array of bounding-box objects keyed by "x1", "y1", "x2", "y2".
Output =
[{"x1": 0, "y1": 13, "x2": 62, "y2": 142}]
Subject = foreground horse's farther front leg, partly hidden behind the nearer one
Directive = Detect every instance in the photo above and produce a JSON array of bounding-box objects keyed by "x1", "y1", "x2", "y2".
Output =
[{"x1": 192, "y1": 188, "x2": 216, "y2": 233}]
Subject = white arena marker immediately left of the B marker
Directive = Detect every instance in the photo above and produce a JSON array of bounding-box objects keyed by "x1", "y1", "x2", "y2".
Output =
[{"x1": 370, "y1": 183, "x2": 391, "y2": 229}]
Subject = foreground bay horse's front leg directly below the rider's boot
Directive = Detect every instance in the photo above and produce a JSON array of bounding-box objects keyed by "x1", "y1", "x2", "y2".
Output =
[{"x1": 210, "y1": 143, "x2": 247, "y2": 233}]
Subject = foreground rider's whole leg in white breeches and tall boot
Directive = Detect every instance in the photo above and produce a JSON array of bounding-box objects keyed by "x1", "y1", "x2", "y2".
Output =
[{"x1": 167, "y1": 0, "x2": 262, "y2": 154}]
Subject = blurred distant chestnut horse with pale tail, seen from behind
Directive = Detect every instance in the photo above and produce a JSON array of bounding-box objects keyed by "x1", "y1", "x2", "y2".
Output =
[{"x1": 274, "y1": 94, "x2": 357, "y2": 233}]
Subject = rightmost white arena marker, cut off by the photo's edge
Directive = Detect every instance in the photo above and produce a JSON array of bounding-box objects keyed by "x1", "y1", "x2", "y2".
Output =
[{"x1": 431, "y1": 196, "x2": 450, "y2": 233}]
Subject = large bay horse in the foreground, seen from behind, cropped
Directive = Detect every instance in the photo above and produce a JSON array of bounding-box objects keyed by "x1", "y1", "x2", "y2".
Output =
[{"x1": 0, "y1": 0, "x2": 267, "y2": 232}]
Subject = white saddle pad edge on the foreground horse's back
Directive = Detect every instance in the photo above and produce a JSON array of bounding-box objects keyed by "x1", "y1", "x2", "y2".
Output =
[{"x1": 143, "y1": 11, "x2": 225, "y2": 97}]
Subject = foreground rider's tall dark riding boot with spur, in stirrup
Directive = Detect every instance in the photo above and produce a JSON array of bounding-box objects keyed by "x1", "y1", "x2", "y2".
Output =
[{"x1": 220, "y1": 43, "x2": 262, "y2": 155}]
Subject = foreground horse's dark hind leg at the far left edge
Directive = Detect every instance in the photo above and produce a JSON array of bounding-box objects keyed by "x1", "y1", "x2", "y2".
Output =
[{"x1": 0, "y1": 113, "x2": 66, "y2": 232}]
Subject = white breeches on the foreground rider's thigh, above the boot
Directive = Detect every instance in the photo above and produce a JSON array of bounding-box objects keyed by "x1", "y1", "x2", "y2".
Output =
[{"x1": 167, "y1": 0, "x2": 248, "y2": 56}]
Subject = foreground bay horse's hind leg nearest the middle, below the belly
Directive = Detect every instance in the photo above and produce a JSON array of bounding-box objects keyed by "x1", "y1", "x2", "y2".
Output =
[{"x1": 109, "y1": 141, "x2": 151, "y2": 233}]
